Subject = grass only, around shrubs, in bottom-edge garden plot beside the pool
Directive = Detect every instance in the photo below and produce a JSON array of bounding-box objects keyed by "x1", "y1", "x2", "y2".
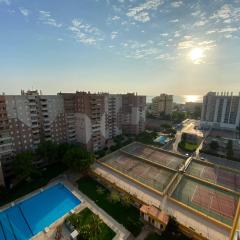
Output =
[{"x1": 69, "y1": 208, "x2": 116, "y2": 240}]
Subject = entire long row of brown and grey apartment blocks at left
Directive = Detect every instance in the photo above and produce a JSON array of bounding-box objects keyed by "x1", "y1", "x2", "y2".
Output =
[{"x1": 0, "y1": 91, "x2": 146, "y2": 184}]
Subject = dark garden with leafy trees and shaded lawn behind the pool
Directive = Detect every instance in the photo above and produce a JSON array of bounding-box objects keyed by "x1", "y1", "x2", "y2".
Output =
[{"x1": 0, "y1": 142, "x2": 95, "y2": 206}]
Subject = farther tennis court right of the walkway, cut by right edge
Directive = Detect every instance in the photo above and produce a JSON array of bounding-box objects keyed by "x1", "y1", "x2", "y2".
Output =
[{"x1": 187, "y1": 161, "x2": 240, "y2": 192}]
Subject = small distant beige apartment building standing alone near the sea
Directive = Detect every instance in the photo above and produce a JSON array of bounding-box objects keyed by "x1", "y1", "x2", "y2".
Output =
[{"x1": 152, "y1": 93, "x2": 173, "y2": 117}]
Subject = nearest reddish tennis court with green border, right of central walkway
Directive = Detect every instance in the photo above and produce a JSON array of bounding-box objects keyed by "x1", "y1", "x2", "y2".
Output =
[{"x1": 172, "y1": 176, "x2": 239, "y2": 226}]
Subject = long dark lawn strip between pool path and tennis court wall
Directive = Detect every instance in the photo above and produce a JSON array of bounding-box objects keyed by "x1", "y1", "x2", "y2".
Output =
[{"x1": 78, "y1": 177, "x2": 143, "y2": 236}]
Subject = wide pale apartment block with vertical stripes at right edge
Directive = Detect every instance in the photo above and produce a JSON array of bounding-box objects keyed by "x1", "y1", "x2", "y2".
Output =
[{"x1": 201, "y1": 92, "x2": 240, "y2": 130}]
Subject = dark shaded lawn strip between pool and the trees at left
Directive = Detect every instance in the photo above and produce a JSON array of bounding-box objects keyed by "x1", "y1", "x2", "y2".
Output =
[{"x1": 0, "y1": 163, "x2": 66, "y2": 206}]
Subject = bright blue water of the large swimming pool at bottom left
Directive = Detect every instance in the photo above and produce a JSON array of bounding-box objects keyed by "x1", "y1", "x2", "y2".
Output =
[{"x1": 0, "y1": 183, "x2": 81, "y2": 240}]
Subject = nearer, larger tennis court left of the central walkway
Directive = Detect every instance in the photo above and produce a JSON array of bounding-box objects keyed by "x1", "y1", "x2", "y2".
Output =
[{"x1": 101, "y1": 151, "x2": 175, "y2": 192}]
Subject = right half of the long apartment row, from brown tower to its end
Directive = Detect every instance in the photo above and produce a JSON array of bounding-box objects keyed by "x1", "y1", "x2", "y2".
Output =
[{"x1": 59, "y1": 92, "x2": 146, "y2": 151}]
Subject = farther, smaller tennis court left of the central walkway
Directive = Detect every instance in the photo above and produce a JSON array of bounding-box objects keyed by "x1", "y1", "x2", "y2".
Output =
[{"x1": 123, "y1": 142, "x2": 186, "y2": 170}]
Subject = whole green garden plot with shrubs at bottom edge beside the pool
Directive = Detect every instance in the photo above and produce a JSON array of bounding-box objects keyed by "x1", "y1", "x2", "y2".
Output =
[{"x1": 66, "y1": 208, "x2": 116, "y2": 240}]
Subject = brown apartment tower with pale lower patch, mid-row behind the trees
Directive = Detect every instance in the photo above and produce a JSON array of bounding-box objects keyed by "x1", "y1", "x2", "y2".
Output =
[{"x1": 59, "y1": 92, "x2": 108, "y2": 151}]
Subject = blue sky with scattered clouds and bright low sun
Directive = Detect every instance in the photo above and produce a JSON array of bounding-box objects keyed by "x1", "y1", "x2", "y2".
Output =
[{"x1": 0, "y1": 0, "x2": 240, "y2": 96}]
